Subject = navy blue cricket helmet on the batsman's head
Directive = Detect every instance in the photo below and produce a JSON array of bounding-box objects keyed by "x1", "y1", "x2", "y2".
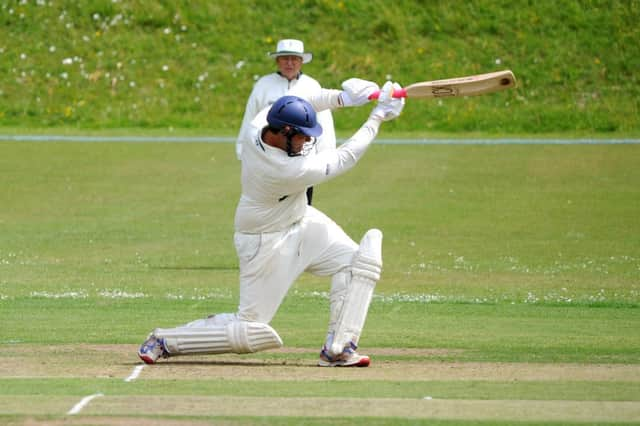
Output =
[{"x1": 267, "y1": 96, "x2": 322, "y2": 137}]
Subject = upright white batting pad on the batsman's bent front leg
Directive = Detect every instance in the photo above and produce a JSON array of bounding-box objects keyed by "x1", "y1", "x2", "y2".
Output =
[{"x1": 329, "y1": 229, "x2": 382, "y2": 356}]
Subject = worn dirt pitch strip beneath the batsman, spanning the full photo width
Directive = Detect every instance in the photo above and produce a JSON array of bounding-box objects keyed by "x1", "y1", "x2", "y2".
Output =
[{"x1": 0, "y1": 345, "x2": 640, "y2": 382}]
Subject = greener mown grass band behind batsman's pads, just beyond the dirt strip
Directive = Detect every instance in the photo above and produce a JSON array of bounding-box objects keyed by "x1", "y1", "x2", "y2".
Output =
[{"x1": 0, "y1": 298, "x2": 640, "y2": 363}]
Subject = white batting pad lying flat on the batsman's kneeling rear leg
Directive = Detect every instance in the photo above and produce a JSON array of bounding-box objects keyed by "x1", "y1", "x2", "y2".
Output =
[{"x1": 153, "y1": 321, "x2": 282, "y2": 355}]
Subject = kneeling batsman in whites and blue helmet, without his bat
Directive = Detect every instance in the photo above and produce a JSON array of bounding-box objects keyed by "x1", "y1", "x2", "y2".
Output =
[{"x1": 138, "y1": 78, "x2": 404, "y2": 367}]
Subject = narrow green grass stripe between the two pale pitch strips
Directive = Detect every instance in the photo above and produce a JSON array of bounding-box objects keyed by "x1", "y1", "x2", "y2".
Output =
[{"x1": 0, "y1": 379, "x2": 640, "y2": 401}]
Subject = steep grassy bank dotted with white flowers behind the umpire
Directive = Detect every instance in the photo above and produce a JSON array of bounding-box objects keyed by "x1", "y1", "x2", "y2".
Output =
[{"x1": 0, "y1": 0, "x2": 640, "y2": 133}]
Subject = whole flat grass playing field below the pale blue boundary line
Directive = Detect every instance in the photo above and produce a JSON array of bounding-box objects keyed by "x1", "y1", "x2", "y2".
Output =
[{"x1": 0, "y1": 135, "x2": 640, "y2": 425}]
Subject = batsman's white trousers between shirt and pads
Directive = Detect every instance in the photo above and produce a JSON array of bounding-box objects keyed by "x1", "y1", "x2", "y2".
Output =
[{"x1": 234, "y1": 206, "x2": 358, "y2": 324}]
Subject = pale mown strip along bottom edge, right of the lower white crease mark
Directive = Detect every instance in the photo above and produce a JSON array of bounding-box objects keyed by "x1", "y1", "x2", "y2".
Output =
[{"x1": 85, "y1": 395, "x2": 640, "y2": 422}]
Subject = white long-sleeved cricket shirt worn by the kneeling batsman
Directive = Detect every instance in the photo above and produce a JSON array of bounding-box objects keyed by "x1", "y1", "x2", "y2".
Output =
[{"x1": 235, "y1": 89, "x2": 380, "y2": 234}]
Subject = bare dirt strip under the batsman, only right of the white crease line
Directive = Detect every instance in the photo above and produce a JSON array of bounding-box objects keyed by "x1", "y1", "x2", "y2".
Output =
[{"x1": 143, "y1": 358, "x2": 640, "y2": 381}]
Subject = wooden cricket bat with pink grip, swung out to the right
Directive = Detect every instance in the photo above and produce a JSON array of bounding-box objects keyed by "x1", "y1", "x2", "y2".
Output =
[{"x1": 369, "y1": 70, "x2": 516, "y2": 99}]
